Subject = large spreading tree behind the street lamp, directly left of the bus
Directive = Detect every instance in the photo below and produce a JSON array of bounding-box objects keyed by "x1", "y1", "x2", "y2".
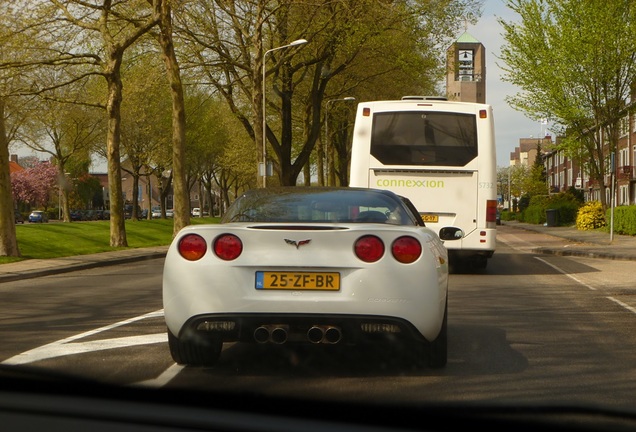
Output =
[{"x1": 180, "y1": 0, "x2": 476, "y2": 185}]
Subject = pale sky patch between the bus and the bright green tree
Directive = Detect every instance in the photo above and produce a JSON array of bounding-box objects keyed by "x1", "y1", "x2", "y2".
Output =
[{"x1": 458, "y1": 0, "x2": 549, "y2": 167}]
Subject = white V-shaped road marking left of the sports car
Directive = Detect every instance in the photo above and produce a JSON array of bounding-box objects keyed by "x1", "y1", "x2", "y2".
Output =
[{"x1": 2, "y1": 310, "x2": 168, "y2": 365}]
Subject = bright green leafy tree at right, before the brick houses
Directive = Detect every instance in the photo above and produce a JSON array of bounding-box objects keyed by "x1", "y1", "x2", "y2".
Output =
[{"x1": 500, "y1": 0, "x2": 636, "y2": 206}]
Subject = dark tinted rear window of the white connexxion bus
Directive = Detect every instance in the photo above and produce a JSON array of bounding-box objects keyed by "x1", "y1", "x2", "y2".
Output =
[{"x1": 371, "y1": 111, "x2": 477, "y2": 167}]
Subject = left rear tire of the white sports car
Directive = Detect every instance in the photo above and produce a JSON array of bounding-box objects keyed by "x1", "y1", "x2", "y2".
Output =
[{"x1": 168, "y1": 330, "x2": 223, "y2": 366}]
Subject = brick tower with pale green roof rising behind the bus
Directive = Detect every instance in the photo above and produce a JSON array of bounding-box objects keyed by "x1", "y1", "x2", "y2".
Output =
[{"x1": 446, "y1": 33, "x2": 486, "y2": 103}]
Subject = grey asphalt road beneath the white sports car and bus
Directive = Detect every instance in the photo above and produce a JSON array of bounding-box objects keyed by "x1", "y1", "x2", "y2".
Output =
[{"x1": 0, "y1": 226, "x2": 636, "y2": 408}]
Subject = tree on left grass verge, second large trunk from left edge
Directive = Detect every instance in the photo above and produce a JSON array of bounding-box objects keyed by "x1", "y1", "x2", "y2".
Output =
[{"x1": 7, "y1": 0, "x2": 160, "y2": 247}]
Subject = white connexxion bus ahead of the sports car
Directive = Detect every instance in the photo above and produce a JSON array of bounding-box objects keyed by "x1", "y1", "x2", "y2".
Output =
[{"x1": 349, "y1": 96, "x2": 497, "y2": 269}]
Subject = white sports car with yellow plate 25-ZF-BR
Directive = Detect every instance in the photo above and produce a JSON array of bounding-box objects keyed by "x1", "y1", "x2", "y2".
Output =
[{"x1": 163, "y1": 187, "x2": 463, "y2": 367}]
